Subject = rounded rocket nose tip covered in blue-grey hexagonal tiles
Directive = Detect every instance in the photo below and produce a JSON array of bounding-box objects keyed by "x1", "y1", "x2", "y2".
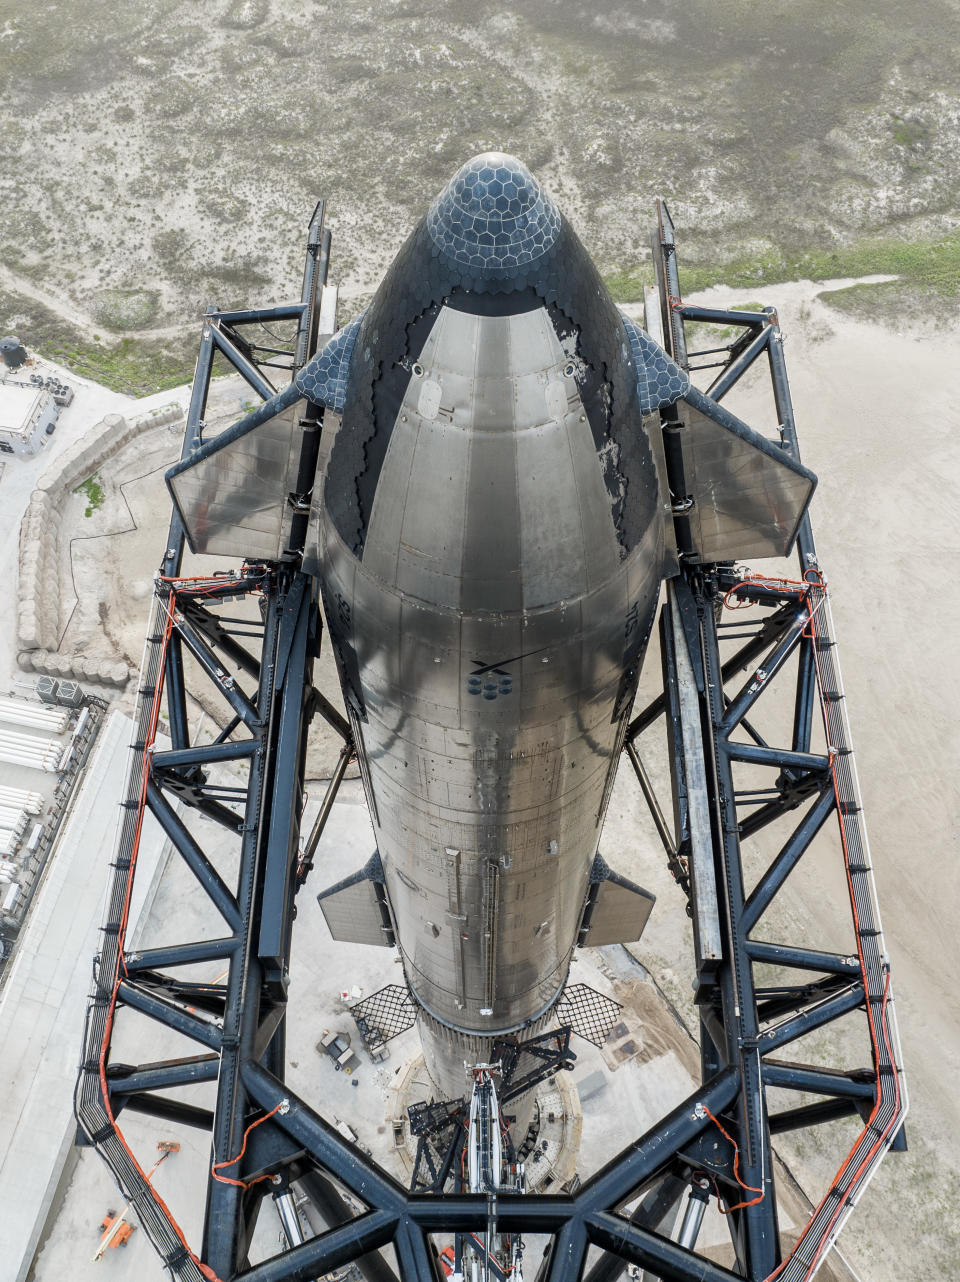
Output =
[{"x1": 427, "y1": 151, "x2": 560, "y2": 278}]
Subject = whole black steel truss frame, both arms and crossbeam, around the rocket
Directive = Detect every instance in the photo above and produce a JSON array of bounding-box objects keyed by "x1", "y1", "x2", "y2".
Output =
[{"x1": 77, "y1": 208, "x2": 905, "y2": 1282}]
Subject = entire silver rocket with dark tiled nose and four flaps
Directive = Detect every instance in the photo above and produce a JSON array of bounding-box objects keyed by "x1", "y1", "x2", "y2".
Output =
[{"x1": 168, "y1": 153, "x2": 815, "y2": 1097}]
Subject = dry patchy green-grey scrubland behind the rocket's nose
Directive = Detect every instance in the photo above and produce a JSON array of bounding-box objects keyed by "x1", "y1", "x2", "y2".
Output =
[{"x1": 0, "y1": 0, "x2": 960, "y2": 391}]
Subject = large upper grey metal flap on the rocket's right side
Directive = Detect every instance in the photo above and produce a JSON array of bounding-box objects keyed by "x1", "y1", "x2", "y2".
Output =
[{"x1": 675, "y1": 387, "x2": 816, "y2": 562}]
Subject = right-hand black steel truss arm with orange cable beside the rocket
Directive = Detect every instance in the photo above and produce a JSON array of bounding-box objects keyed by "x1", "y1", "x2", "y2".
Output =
[{"x1": 617, "y1": 205, "x2": 906, "y2": 1282}]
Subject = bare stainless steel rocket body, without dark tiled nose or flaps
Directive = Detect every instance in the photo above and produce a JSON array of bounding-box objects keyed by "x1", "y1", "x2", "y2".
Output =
[{"x1": 314, "y1": 178, "x2": 663, "y2": 1095}]
